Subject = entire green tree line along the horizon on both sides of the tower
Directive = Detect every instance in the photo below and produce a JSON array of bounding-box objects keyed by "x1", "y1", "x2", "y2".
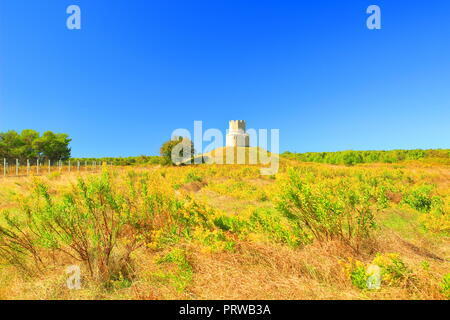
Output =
[{"x1": 0, "y1": 129, "x2": 450, "y2": 166}]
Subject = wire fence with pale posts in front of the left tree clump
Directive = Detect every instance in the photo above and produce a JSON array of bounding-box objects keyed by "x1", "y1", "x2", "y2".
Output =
[{"x1": 0, "y1": 158, "x2": 112, "y2": 178}]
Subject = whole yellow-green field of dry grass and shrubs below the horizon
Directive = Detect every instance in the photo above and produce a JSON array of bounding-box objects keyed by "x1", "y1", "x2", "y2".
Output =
[{"x1": 0, "y1": 158, "x2": 450, "y2": 300}]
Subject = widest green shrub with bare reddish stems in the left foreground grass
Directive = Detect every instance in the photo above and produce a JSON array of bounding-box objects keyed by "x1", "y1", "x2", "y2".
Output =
[{"x1": 0, "y1": 172, "x2": 177, "y2": 282}]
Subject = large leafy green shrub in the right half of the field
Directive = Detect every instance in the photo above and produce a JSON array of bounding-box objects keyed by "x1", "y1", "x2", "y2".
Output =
[{"x1": 277, "y1": 170, "x2": 375, "y2": 249}]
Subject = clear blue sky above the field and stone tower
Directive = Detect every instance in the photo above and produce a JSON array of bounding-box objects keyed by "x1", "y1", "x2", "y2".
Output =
[{"x1": 0, "y1": 0, "x2": 450, "y2": 157}]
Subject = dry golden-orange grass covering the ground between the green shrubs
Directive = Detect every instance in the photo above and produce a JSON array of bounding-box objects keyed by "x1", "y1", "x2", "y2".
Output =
[{"x1": 0, "y1": 160, "x2": 450, "y2": 300}]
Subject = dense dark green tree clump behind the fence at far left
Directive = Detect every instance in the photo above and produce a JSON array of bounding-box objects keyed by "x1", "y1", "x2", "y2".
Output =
[{"x1": 0, "y1": 129, "x2": 72, "y2": 161}]
